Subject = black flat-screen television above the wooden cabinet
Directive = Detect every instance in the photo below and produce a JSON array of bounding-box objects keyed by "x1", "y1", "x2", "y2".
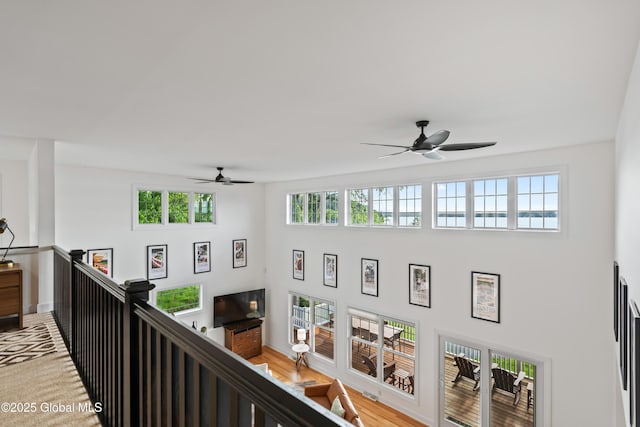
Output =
[{"x1": 213, "y1": 288, "x2": 265, "y2": 328}]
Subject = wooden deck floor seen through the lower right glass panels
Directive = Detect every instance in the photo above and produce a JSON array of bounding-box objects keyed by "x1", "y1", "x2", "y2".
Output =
[{"x1": 444, "y1": 356, "x2": 534, "y2": 427}]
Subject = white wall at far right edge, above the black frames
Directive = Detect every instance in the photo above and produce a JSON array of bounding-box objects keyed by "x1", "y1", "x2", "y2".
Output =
[{"x1": 609, "y1": 41, "x2": 640, "y2": 426}]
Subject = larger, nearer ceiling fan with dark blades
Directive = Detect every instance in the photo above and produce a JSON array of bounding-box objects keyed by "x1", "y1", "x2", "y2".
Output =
[{"x1": 363, "y1": 120, "x2": 496, "y2": 160}]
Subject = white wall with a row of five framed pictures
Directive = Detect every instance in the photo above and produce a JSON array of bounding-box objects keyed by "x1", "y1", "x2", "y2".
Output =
[{"x1": 265, "y1": 143, "x2": 613, "y2": 426}]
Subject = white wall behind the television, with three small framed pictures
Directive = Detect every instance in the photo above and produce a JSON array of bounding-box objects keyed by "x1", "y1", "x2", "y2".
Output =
[{"x1": 55, "y1": 165, "x2": 264, "y2": 343}]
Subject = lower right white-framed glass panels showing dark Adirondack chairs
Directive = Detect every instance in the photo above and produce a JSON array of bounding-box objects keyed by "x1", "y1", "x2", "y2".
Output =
[{"x1": 438, "y1": 335, "x2": 551, "y2": 427}]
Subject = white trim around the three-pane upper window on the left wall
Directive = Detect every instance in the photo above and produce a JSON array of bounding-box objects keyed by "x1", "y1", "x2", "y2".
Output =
[{"x1": 131, "y1": 184, "x2": 218, "y2": 230}]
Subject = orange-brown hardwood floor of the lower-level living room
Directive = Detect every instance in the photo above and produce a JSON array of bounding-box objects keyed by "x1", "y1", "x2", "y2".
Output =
[{"x1": 249, "y1": 346, "x2": 427, "y2": 427}]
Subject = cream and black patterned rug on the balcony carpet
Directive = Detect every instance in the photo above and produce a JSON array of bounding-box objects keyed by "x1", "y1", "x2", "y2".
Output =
[{"x1": 0, "y1": 323, "x2": 56, "y2": 368}]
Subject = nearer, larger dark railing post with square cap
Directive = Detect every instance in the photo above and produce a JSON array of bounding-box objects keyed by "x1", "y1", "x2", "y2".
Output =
[{"x1": 120, "y1": 279, "x2": 155, "y2": 427}]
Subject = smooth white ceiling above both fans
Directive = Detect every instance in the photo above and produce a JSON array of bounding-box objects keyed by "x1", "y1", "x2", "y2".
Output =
[{"x1": 0, "y1": 0, "x2": 640, "y2": 182}]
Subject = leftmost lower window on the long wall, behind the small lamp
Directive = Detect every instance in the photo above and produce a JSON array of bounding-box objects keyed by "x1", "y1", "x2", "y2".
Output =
[{"x1": 289, "y1": 292, "x2": 336, "y2": 360}]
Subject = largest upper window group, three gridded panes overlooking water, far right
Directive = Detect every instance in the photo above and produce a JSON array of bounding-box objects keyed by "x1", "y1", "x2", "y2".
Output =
[{"x1": 433, "y1": 172, "x2": 560, "y2": 231}]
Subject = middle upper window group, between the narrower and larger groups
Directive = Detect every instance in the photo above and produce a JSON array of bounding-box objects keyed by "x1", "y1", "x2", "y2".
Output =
[{"x1": 345, "y1": 184, "x2": 422, "y2": 227}]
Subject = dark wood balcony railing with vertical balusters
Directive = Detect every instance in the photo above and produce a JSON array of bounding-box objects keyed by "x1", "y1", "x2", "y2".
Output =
[{"x1": 54, "y1": 247, "x2": 350, "y2": 427}]
